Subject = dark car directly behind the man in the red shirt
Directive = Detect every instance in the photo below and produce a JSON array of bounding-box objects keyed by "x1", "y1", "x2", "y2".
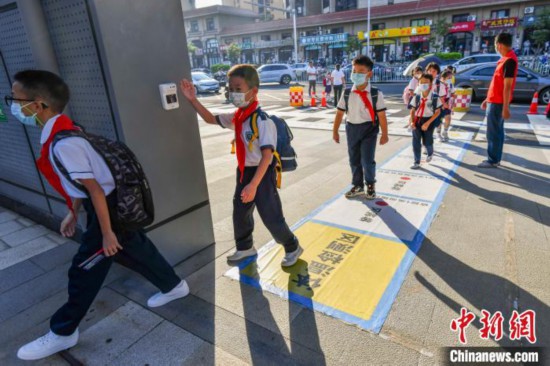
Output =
[{"x1": 455, "y1": 63, "x2": 550, "y2": 105}]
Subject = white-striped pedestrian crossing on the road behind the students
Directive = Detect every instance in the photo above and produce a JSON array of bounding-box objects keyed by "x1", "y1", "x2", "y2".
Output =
[{"x1": 198, "y1": 97, "x2": 550, "y2": 146}]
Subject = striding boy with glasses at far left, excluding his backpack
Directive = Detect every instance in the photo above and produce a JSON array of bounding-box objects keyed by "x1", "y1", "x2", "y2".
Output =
[{"x1": 11, "y1": 70, "x2": 189, "y2": 360}]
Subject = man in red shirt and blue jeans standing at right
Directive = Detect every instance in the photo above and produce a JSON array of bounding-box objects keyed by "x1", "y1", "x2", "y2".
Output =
[{"x1": 478, "y1": 33, "x2": 518, "y2": 168}]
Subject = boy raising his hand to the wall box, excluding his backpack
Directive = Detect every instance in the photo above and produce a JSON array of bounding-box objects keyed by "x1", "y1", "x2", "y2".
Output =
[{"x1": 180, "y1": 65, "x2": 303, "y2": 267}]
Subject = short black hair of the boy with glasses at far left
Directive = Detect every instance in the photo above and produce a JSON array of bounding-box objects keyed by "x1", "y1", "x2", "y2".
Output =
[{"x1": 13, "y1": 70, "x2": 70, "y2": 113}]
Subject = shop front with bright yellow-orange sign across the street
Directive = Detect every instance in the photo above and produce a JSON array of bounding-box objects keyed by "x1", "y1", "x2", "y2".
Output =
[{"x1": 368, "y1": 25, "x2": 431, "y2": 62}]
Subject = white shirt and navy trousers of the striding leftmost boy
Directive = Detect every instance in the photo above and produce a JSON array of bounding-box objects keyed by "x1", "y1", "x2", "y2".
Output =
[{"x1": 41, "y1": 115, "x2": 181, "y2": 336}]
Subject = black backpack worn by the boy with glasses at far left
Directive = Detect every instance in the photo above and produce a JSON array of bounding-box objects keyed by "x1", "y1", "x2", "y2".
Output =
[{"x1": 52, "y1": 130, "x2": 155, "y2": 231}]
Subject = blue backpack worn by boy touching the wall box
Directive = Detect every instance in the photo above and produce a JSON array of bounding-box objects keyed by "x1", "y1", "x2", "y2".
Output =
[{"x1": 248, "y1": 109, "x2": 298, "y2": 188}]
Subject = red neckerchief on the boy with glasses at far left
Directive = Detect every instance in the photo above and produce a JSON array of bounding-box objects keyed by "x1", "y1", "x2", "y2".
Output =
[{"x1": 36, "y1": 114, "x2": 78, "y2": 212}]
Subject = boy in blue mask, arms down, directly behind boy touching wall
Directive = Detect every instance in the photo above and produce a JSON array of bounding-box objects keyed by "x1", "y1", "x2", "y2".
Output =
[{"x1": 332, "y1": 55, "x2": 389, "y2": 199}]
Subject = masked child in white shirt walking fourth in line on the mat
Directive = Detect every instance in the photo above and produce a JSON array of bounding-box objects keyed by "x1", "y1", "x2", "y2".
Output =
[{"x1": 410, "y1": 74, "x2": 442, "y2": 169}]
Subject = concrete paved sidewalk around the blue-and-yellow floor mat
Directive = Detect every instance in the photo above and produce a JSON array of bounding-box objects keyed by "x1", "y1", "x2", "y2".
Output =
[{"x1": 0, "y1": 117, "x2": 550, "y2": 365}]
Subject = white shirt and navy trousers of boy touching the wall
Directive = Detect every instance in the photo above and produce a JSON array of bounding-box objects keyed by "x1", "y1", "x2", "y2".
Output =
[{"x1": 216, "y1": 113, "x2": 298, "y2": 253}]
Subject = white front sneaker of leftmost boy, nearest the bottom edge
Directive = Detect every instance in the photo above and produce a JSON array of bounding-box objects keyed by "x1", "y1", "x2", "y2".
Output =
[{"x1": 17, "y1": 329, "x2": 78, "y2": 361}]
